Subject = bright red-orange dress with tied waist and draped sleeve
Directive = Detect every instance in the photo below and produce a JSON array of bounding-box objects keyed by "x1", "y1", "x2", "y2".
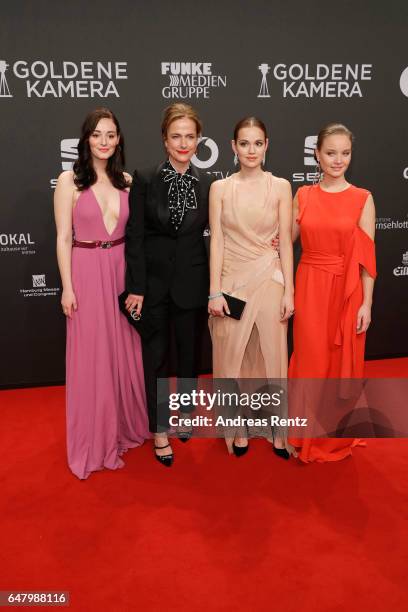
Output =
[{"x1": 289, "y1": 185, "x2": 376, "y2": 462}]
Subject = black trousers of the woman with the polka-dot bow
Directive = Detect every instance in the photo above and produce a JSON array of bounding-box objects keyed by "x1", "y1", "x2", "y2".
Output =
[{"x1": 142, "y1": 295, "x2": 202, "y2": 433}]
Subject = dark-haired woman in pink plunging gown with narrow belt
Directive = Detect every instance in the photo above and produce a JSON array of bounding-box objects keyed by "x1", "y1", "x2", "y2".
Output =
[{"x1": 55, "y1": 109, "x2": 149, "y2": 479}]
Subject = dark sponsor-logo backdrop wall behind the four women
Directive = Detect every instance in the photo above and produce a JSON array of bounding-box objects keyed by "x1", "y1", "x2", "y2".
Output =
[{"x1": 0, "y1": 0, "x2": 408, "y2": 386}]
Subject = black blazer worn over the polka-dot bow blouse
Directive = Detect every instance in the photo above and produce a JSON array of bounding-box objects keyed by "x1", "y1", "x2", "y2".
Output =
[{"x1": 125, "y1": 163, "x2": 214, "y2": 308}]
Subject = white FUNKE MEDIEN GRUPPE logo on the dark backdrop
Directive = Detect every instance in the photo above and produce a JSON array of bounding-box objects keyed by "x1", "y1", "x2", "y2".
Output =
[{"x1": 161, "y1": 62, "x2": 227, "y2": 99}]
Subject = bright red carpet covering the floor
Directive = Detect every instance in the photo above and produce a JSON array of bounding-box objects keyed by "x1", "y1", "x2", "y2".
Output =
[{"x1": 0, "y1": 359, "x2": 408, "y2": 612}]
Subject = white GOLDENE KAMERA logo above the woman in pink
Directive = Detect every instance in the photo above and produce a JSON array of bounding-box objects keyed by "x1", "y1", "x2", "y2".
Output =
[{"x1": 0, "y1": 60, "x2": 128, "y2": 98}]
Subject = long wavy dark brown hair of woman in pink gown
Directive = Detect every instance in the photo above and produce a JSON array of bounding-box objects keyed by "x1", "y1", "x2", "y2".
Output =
[{"x1": 73, "y1": 108, "x2": 128, "y2": 191}]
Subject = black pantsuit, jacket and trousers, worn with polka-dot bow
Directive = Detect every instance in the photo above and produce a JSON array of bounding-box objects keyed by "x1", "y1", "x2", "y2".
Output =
[{"x1": 126, "y1": 164, "x2": 212, "y2": 432}]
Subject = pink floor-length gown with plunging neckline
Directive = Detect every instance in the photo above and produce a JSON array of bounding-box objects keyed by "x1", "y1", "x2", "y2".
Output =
[{"x1": 66, "y1": 188, "x2": 149, "y2": 479}]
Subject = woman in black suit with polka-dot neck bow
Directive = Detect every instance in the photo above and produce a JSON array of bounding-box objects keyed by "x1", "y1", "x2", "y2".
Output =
[{"x1": 126, "y1": 103, "x2": 212, "y2": 467}]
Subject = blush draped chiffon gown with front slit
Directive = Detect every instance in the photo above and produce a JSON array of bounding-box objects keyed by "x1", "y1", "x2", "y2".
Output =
[{"x1": 209, "y1": 172, "x2": 288, "y2": 452}]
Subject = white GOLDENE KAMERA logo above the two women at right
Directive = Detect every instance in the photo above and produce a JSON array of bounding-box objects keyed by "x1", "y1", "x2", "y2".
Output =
[{"x1": 258, "y1": 63, "x2": 372, "y2": 98}]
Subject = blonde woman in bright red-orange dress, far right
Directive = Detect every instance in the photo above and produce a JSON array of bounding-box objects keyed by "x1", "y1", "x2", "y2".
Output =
[{"x1": 289, "y1": 124, "x2": 376, "y2": 462}]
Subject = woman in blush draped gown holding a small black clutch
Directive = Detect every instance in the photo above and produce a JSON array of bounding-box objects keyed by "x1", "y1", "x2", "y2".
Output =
[{"x1": 208, "y1": 117, "x2": 293, "y2": 459}]
